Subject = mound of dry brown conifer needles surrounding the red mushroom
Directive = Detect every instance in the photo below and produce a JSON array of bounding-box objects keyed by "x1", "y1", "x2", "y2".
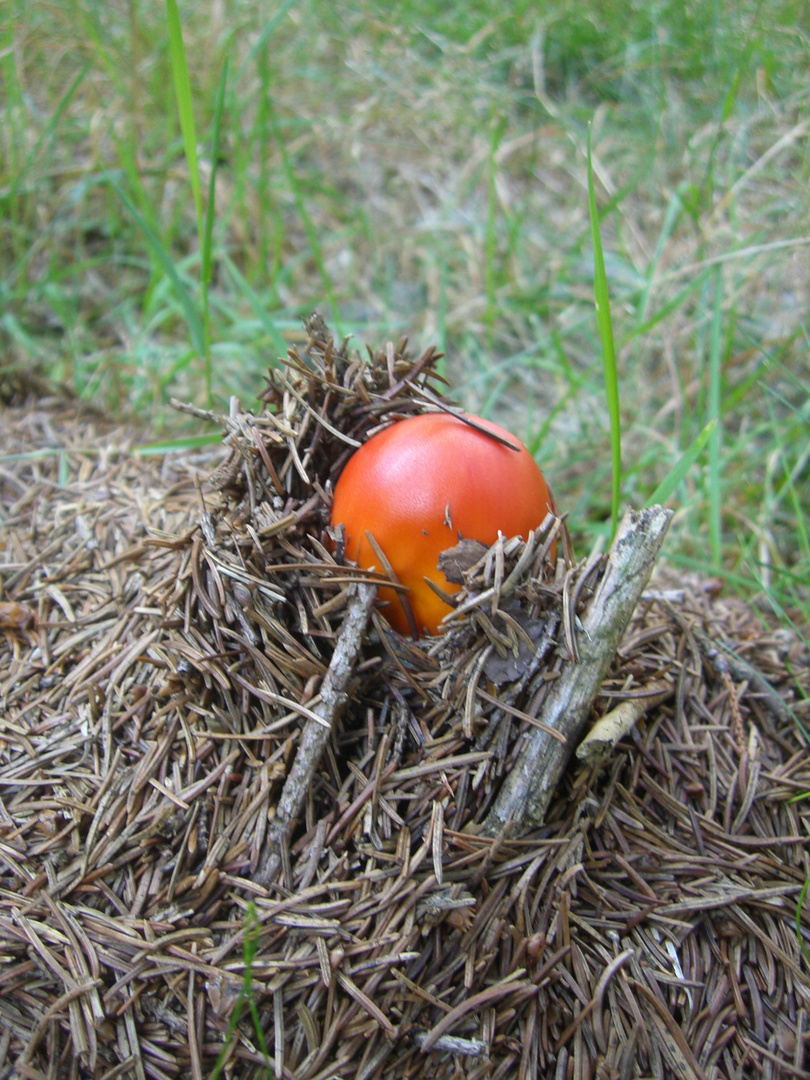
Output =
[{"x1": 0, "y1": 319, "x2": 810, "y2": 1080}]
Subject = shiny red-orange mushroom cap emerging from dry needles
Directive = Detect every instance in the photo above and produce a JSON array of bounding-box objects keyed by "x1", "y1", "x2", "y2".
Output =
[{"x1": 332, "y1": 413, "x2": 553, "y2": 634}]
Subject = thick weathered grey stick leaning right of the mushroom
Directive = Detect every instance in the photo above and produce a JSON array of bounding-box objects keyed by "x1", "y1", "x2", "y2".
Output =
[{"x1": 480, "y1": 507, "x2": 672, "y2": 836}]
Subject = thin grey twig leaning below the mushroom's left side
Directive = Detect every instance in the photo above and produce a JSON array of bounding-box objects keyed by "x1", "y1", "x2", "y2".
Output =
[{"x1": 254, "y1": 582, "x2": 377, "y2": 888}]
